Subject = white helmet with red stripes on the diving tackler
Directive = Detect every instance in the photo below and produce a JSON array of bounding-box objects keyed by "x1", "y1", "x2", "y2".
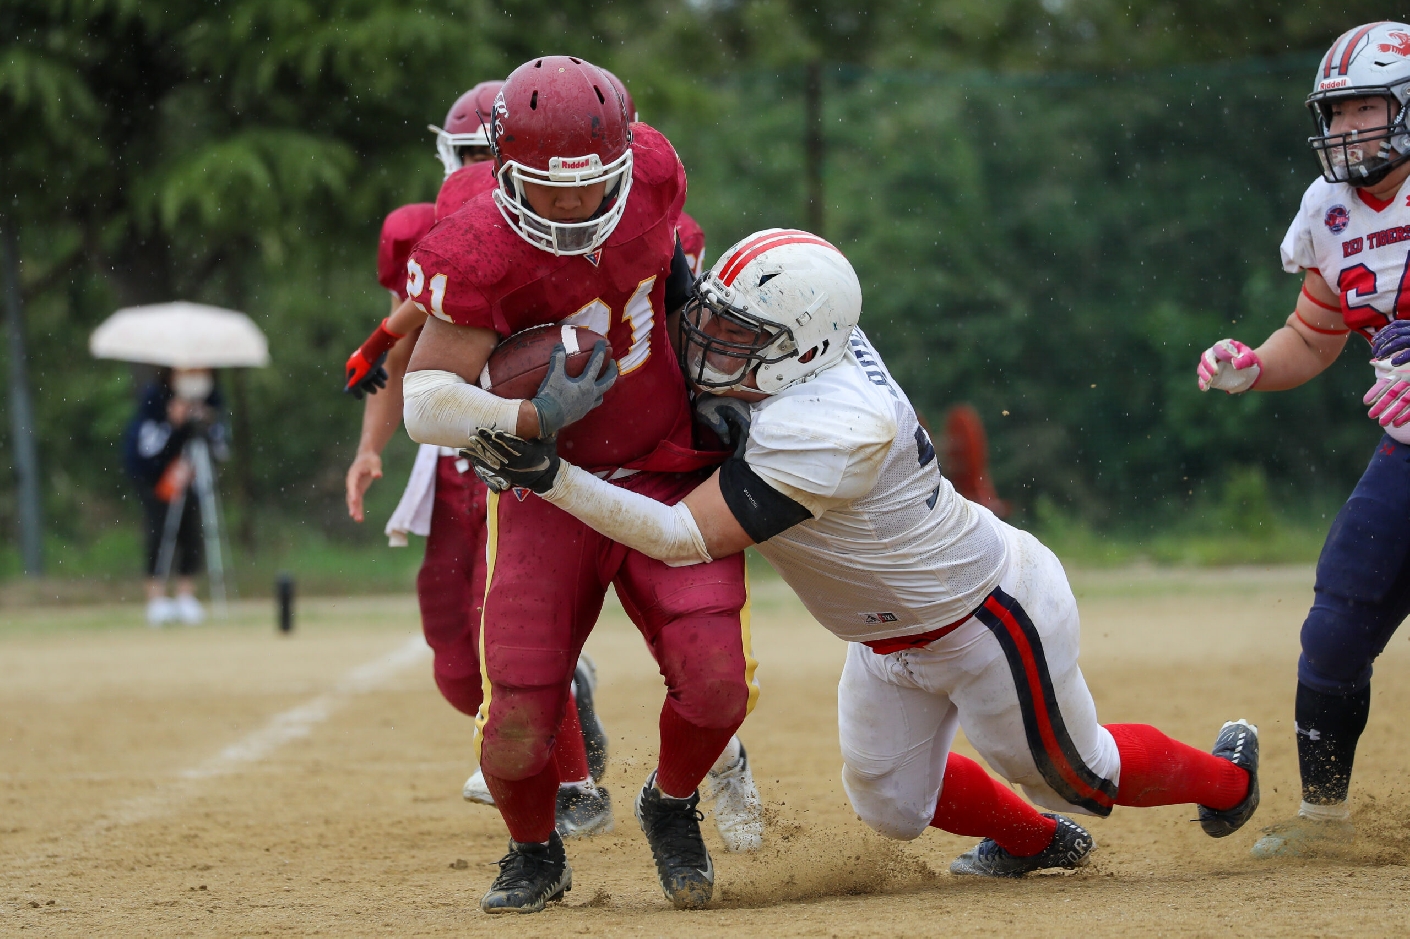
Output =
[{"x1": 681, "y1": 228, "x2": 862, "y2": 395}]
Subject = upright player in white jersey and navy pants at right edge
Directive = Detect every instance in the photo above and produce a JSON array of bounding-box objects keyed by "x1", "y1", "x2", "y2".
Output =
[{"x1": 1199, "y1": 23, "x2": 1410, "y2": 857}]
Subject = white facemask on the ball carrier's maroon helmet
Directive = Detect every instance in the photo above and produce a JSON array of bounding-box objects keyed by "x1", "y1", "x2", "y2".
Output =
[{"x1": 494, "y1": 149, "x2": 632, "y2": 255}]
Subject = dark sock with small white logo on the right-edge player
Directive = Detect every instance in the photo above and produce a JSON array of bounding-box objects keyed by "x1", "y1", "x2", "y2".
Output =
[{"x1": 1294, "y1": 681, "x2": 1371, "y2": 805}]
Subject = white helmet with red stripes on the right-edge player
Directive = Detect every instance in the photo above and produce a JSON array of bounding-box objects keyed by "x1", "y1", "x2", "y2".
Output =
[{"x1": 1307, "y1": 23, "x2": 1410, "y2": 186}]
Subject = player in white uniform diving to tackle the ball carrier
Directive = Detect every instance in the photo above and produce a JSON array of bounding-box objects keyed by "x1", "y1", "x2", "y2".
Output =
[{"x1": 472, "y1": 230, "x2": 1258, "y2": 876}]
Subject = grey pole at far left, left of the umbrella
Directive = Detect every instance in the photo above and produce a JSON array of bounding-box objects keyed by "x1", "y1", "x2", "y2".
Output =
[{"x1": 0, "y1": 214, "x2": 44, "y2": 577}]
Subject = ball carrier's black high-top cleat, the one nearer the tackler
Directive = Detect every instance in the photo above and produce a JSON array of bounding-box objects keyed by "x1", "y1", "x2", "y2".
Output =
[{"x1": 636, "y1": 773, "x2": 715, "y2": 909}]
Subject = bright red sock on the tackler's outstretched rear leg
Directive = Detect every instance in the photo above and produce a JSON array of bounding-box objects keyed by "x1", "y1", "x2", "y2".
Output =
[{"x1": 1105, "y1": 723, "x2": 1248, "y2": 809}]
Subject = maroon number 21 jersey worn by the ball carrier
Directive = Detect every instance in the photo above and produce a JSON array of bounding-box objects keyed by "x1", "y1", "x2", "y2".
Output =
[{"x1": 407, "y1": 124, "x2": 705, "y2": 472}]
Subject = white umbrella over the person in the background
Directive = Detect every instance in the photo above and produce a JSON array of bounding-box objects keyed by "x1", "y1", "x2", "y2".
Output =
[{"x1": 89, "y1": 300, "x2": 269, "y2": 368}]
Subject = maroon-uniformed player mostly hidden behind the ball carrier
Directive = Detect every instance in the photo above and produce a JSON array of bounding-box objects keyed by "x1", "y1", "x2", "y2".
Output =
[{"x1": 345, "y1": 82, "x2": 612, "y2": 837}]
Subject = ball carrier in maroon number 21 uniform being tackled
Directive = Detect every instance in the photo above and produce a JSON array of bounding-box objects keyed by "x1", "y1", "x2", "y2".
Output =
[{"x1": 405, "y1": 56, "x2": 757, "y2": 912}]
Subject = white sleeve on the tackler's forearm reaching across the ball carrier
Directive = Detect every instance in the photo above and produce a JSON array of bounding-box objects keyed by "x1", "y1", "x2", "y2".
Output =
[{"x1": 541, "y1": 462, "x2": 713, "y2": 567}]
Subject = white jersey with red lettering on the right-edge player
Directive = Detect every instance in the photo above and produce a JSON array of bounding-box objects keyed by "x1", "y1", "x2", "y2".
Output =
[{"x1": 1280, "y1": 179, "x2": 1410, "y2": 338}]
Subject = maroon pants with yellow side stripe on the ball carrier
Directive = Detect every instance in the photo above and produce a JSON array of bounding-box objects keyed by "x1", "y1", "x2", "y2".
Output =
[{"x1": 478, "y1": 472, "x2": 757, "y2": 842}]
